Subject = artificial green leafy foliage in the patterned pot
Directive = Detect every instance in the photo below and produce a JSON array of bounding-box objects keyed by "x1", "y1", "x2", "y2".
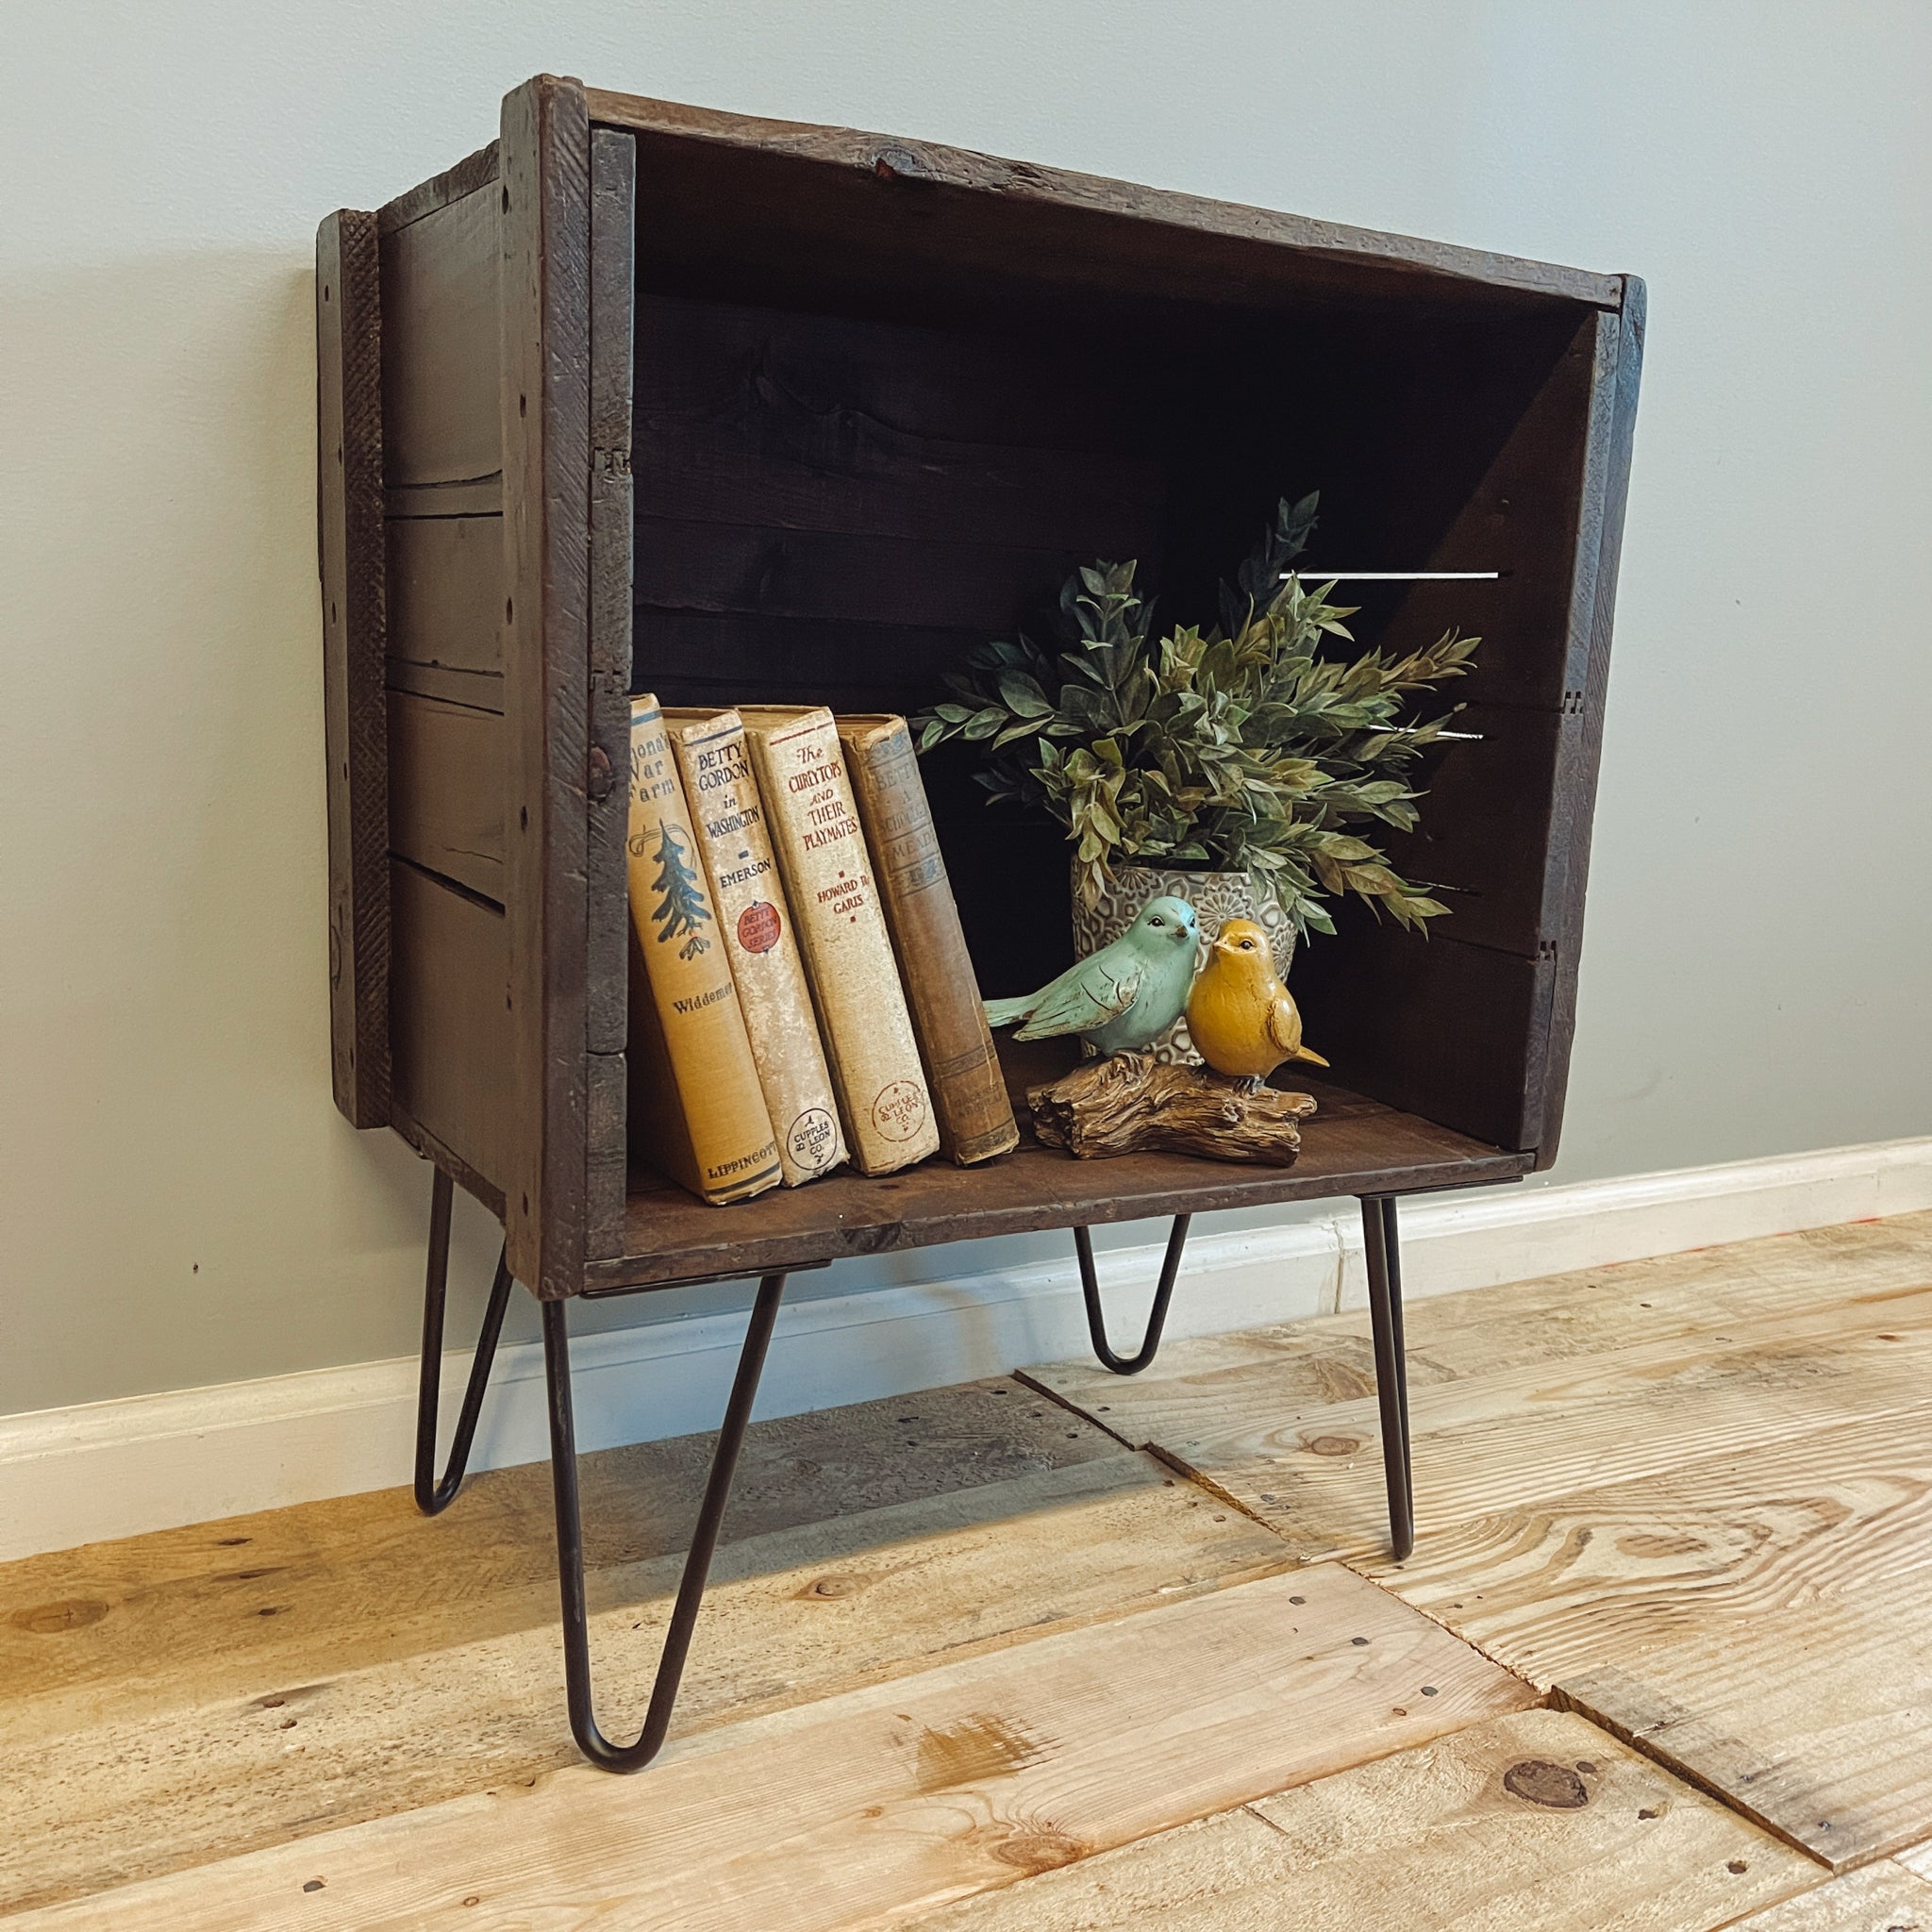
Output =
[{"x1": 914, "y1": 494, "x2": 1480, "y2": 935}]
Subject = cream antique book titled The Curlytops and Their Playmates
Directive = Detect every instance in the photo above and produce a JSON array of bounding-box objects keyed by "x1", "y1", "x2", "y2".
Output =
[{"x1": 738, "y1": 706, "x2": 939, "y2": 1174}]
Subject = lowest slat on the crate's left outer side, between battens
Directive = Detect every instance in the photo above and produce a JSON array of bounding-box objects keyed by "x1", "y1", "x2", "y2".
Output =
[{"x1": 391, "y1": 859, "x2": 512, "y2": 1186}]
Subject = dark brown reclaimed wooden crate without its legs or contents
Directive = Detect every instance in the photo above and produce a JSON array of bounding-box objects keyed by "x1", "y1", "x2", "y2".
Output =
[{"x1": 317, "y1": 77, "x2": 1644, "y2": 1298}]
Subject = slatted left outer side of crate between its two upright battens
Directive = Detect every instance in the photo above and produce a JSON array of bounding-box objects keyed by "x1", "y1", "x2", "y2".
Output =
[{"x1": 380, "y1": 149, "x2": 512, "y2": 1211}]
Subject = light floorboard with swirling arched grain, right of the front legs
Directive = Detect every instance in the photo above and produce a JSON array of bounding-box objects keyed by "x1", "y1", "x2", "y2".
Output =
[{"x1": 1364, "y1": 1399, "x2": 1932, "y2": 1868}]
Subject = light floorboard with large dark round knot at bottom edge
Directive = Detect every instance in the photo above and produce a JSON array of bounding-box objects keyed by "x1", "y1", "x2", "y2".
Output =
[{"x1": 904, "y1": 1709, "x2": 1818, "y2": 1932}]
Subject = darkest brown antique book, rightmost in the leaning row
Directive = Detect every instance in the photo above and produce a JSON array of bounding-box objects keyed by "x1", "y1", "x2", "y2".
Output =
[{"x1": 839, "y1": 713, "x2": 1020, "y2": 1167}]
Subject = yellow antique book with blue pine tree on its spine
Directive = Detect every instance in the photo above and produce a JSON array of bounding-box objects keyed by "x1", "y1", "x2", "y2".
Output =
[{"x1": 628, "y1": 697, "x2": 784, "y2": 1206}]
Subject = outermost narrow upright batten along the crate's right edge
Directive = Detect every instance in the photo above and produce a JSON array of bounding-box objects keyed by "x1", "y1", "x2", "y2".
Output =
[{"x1": 1536, "y1": 276, "x2": 1646, "y2": 1169}]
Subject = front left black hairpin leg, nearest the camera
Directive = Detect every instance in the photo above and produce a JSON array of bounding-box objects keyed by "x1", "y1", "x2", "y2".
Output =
[{"x1": 542, "y1": 1275, "x2": 784, "y2": 1772}]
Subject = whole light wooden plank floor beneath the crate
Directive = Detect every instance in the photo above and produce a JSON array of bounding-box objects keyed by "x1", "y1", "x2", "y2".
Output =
[{"x1": 0, "y1": 1215, "x2": 1932, "y2": 1932}]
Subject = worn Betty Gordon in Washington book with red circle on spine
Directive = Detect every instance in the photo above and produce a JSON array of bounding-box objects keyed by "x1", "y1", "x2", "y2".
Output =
[{"x1": 665, "y1": 708, "x2": 846, "y2": 1189}]
